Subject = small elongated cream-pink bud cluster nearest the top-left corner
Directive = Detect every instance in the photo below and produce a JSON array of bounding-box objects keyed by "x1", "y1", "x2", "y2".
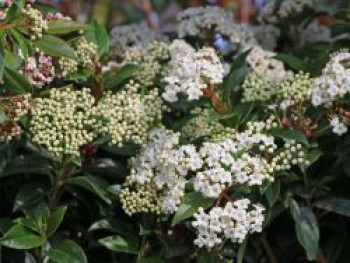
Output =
[{"x1": 23, "y1": 5, "x2": 48, "y2": 40}]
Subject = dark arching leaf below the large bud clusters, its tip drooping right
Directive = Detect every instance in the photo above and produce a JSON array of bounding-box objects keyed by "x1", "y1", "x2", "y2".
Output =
[{"x1": 67, "y1": 175, "x2": 112, "y2": 204}]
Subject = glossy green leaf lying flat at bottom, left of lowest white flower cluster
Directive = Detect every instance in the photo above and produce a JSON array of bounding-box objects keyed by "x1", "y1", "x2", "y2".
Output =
[{"x1": 99, "y1": 235, "x2": 139, "y2": 254}]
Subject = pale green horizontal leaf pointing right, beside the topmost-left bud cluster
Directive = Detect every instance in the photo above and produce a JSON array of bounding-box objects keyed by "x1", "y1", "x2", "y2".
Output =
[{"x1": 46, "y1": 19, "x2": 88, "y2": 35}]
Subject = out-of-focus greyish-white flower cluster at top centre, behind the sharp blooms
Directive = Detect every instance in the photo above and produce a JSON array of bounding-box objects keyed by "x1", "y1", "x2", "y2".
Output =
[{"x1": 178, "y1": 6, "x2": 256, "y2": 50}]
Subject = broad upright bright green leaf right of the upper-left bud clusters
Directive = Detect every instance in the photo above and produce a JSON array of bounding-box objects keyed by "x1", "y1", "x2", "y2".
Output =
[{"x1": 85, "y1": 21, "x2": 109, "y2": 57}]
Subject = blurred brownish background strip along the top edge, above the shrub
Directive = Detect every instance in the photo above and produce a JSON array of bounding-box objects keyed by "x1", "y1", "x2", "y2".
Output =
[{"x1": 41, "y1": 0, "x2": 265, "y2": 31}]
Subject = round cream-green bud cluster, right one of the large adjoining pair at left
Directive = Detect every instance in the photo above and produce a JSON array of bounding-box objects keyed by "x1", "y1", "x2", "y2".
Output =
[{"x1": 94, "y1": 82, "x2": 167, "y2": 146}]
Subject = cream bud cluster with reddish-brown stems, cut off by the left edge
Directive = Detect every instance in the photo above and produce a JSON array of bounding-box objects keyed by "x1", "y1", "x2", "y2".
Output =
[{"x1": 0, "y1": 95, "x2": 31, "y2": 142}]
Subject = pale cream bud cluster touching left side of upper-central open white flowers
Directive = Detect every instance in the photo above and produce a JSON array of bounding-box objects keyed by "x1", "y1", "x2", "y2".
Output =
[{"x1": 123, "y1": 41, "x2": 169, "y2": 87}]
